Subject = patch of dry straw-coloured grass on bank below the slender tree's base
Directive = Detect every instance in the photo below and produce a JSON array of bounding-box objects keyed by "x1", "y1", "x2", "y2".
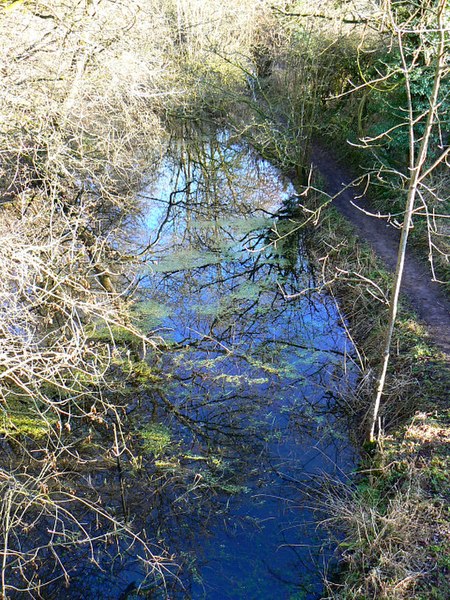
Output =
[{"x1": 324, "y1": 406, "x2": 450, "y2": 600}]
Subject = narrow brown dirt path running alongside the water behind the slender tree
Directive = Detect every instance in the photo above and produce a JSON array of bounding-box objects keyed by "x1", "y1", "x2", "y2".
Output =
[{"x1": 312, "y1": 144, "x2": 450, "y2": 356}]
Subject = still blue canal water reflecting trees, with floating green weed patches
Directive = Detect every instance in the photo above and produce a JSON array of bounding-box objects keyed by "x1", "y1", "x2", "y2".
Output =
[{"x1": 4, "y1": 132, "x2": 356, "y2": 600}]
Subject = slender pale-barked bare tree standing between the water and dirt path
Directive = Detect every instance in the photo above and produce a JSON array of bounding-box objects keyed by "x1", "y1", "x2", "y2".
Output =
[{"x1": 369, "y1": 0, "x2": 450, "y2": 442}]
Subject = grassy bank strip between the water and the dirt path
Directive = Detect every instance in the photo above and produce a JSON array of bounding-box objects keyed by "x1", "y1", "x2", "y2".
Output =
[{"x1": 304, "y1": 208, "x2": 450, "y2": 600}]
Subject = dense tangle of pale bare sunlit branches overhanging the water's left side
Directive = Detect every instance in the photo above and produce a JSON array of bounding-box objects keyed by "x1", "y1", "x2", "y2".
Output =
[{"x1": 0, "y1": 0, "x2": 276, "y2": 598}]
